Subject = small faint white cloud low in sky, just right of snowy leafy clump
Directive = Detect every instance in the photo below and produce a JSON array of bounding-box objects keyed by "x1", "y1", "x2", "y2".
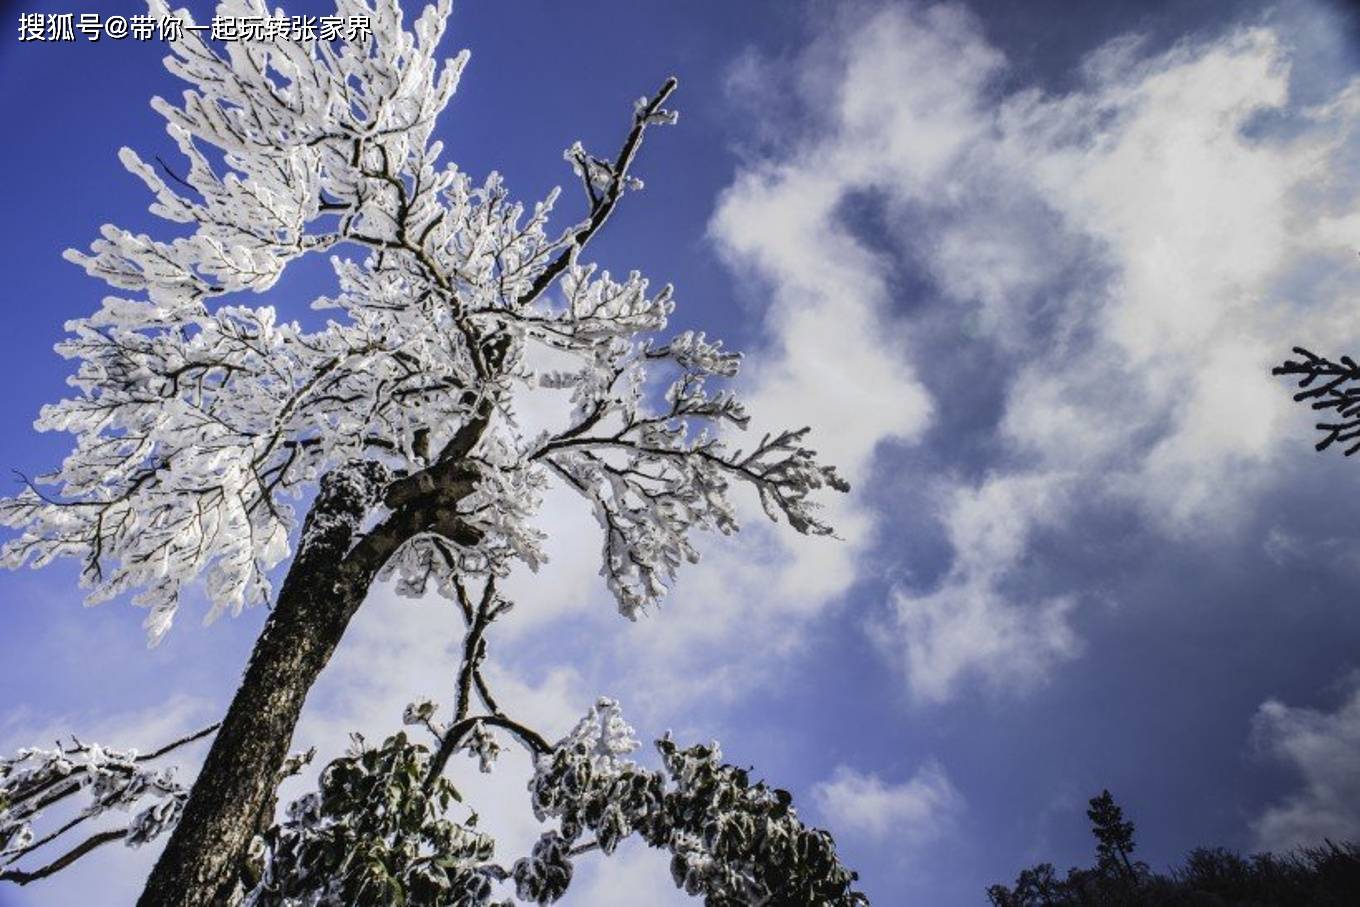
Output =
[{"x1": 812, "y1": 761, "x2": 964, "y2": 849}]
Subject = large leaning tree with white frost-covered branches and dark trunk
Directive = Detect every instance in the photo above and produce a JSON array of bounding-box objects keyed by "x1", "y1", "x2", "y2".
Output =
[{"x1": 0, "y1": 0, "x2": 847, "y2": 907}]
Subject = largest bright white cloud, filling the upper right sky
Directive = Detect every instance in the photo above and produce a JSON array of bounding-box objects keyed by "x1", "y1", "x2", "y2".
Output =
[{"x1": 714, "y1": 4, "x2": 1360, "y2": 700}]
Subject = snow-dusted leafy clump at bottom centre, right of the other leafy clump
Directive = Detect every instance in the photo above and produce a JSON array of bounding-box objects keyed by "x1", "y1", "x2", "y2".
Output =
[{"x1": 514, "y1": 699, "x2": 869, "y2": 907}]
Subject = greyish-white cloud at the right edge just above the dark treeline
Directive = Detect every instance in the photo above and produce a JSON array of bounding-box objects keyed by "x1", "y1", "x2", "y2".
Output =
[{"x1": 1251, "y1": 681, "x2": 1360, "y2": 851}]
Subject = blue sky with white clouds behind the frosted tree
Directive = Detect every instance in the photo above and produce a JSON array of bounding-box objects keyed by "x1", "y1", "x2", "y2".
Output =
[{"x1": 0, "y1": 0, "x2": 1360, "y2": 906}]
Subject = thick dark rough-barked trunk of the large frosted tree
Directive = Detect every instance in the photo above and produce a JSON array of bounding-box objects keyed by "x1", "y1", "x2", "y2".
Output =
[{"x1": 137, "y1": 464, "x2": 401, "y2": 907}]
